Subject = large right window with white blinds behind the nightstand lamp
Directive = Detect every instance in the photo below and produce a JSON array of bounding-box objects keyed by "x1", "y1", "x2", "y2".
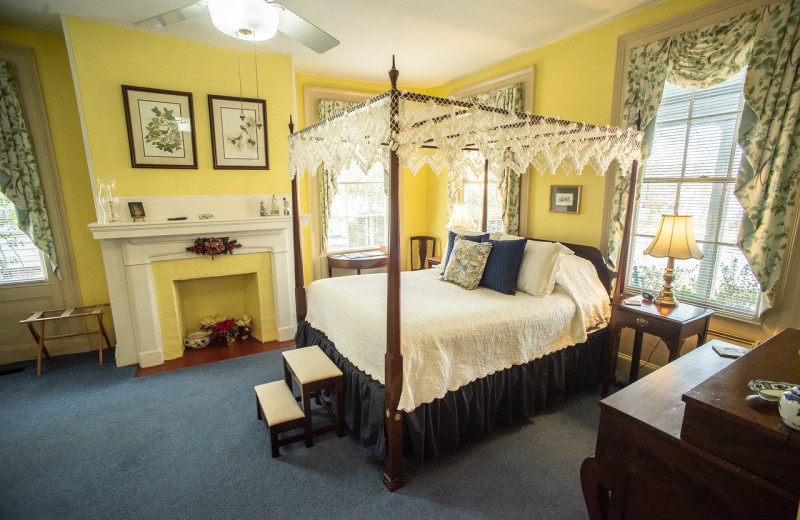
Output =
[{"x1": 627, "y1": 70, "x2": 760, "y2": 319}]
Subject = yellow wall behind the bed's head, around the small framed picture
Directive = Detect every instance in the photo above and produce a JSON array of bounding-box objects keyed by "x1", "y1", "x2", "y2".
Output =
[{"x1": 429, "y1": 0, "x2": 713, "y2": 247}]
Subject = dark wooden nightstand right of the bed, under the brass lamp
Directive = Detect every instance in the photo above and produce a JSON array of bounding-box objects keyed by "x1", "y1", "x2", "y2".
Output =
[{"x1": 602, "y1": 296, "x2": 714, "y2": 397}]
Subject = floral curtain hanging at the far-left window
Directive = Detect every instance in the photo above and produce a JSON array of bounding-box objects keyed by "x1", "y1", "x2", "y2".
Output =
[{"x1": 0, "y1": 60, "x2": 61, "y2": 279}]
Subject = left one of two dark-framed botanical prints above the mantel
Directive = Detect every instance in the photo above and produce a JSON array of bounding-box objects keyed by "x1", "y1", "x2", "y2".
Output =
[{"x1": 122, "y1": 85, "x2": 197, "y2": 168}]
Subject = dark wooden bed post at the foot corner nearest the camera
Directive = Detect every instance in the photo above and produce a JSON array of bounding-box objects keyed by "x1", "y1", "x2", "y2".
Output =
[{"x1": 383, "y1": 56, "x2": 405, "y2": 491}]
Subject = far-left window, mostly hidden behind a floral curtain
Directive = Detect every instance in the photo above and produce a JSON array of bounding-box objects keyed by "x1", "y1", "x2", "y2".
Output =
[{"x1": 0, "y1": 193, "x2": 45, "y2": 284}]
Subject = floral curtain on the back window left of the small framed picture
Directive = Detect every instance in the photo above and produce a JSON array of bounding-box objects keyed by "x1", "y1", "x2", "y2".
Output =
[{"x1": 454, "y1": 83, "x2": 525, "y2": 235}]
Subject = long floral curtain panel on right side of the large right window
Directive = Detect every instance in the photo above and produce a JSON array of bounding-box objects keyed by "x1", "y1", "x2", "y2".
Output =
[{"x1": 736, "y1": 0, "x2": 800, "y2": 306}]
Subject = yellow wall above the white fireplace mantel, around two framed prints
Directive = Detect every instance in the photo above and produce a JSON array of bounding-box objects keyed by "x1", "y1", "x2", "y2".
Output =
[{"x1": 65, "y1": 18, "x2": 292, "y2": 334}]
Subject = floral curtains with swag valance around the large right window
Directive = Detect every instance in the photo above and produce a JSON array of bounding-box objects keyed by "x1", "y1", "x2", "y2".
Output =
[{"x1": 608, "y1": 0, "x2": 800, "y2": 307}]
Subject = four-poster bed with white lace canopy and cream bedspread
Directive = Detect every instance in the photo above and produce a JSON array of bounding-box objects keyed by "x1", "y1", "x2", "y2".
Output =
[{"x1": 289, "y1": 60, "x2": 642, "y2": 490}]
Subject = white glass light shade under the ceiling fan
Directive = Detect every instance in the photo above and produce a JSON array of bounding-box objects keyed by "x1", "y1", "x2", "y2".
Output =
[{"x1": 208, "y1": 0, "x2": 278, "y2": 41}]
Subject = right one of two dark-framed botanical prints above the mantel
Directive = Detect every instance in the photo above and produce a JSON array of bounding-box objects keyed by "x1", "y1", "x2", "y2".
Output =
[{"x1": 208, "y1": 95, "x2": 269, "y2": 170}]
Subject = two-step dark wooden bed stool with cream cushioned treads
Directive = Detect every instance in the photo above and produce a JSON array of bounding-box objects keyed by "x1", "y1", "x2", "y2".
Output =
[{"x1": 255, "y1": 345, "x2": 345, "y2": 457}]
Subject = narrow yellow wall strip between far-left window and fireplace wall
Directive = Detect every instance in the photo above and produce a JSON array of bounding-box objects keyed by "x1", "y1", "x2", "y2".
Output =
[{"x1": 0, "y1": 26, "x2": 101, "y2": 305}]
